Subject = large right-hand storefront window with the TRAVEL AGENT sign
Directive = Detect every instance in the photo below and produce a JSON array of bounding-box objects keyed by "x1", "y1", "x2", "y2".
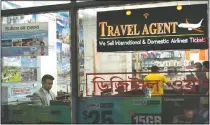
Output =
[{"x1": 79, "y1": 1, "x2": 209, "y2": 124}]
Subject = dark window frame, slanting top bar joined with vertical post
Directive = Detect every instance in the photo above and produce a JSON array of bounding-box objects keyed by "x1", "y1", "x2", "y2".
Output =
[{"x1": 1, "y1": 0, "x2": 209, "y2": 124}]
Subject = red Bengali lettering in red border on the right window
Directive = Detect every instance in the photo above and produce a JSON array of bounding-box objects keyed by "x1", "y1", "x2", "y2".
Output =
[{"x1": 86, "y1": 71, "x2": 209, "y2": 96}]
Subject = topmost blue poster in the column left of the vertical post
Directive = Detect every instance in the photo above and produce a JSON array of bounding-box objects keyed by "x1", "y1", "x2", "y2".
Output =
[{"x1": 56, "y1": 12, "x2": 71, "y2": 44}]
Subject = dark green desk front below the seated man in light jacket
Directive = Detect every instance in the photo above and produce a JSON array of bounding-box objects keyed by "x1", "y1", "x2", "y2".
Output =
[{"x1": 2, "y1": 92, "x2": 71, "y2": 124}]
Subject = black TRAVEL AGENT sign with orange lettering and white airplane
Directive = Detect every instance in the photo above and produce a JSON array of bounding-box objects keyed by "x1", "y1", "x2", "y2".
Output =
[{"x1": 97, "y1": 4, "x2": 208, "y2": 52}]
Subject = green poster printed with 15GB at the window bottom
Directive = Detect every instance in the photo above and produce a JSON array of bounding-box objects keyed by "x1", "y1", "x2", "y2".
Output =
[{"x1": 121, "y1": 97, "x2": 162, "y2": 124}]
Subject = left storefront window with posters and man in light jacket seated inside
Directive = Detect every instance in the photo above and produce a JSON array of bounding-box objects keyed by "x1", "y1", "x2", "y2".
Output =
[{"x1": 1, "y1": 11, "x2": 71, "y2": 124}]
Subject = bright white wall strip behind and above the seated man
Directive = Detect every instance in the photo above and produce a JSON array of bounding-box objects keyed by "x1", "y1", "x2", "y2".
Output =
[{"x1": 36, "y1": 13, "x2": 57, "y2": 95}]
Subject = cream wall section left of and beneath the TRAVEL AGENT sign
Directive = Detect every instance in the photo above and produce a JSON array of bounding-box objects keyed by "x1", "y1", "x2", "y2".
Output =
[{"x1": 83, "y1": 17, "x2": 132, "y2": 95}]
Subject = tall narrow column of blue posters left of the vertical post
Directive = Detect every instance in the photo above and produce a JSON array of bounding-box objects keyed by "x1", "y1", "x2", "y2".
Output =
[{"x1": 56, "y1": 12, "x2": 71, "y2": 84}]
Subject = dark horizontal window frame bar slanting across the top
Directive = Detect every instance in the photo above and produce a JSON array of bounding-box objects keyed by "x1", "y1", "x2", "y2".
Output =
[{"x1": 1, "y1": 0, "x2": 162, "y2": 17}]
